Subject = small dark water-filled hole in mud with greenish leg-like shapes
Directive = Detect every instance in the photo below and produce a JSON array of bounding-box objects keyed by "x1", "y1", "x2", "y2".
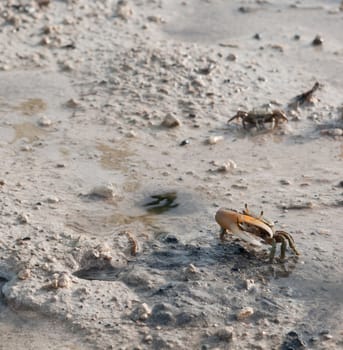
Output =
[{"x1": 143, "y1": 191, "x2": 180, "y2": 215}]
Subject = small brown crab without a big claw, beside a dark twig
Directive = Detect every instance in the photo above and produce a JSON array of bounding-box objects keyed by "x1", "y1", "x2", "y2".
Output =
[{"x1": 228, "y1": 109, "x2": 288, "y2": 130}]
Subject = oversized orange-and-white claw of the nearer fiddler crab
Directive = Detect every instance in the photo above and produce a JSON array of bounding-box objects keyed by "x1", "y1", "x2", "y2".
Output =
[{"x1": 215, "y1": 208, "x2": 274, "y2": 246}]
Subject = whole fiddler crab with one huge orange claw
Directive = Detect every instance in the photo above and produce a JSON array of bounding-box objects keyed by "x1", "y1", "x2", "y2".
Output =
[{"x1": 215, "y1": 204, "x2": 300, "y2": 262}]
